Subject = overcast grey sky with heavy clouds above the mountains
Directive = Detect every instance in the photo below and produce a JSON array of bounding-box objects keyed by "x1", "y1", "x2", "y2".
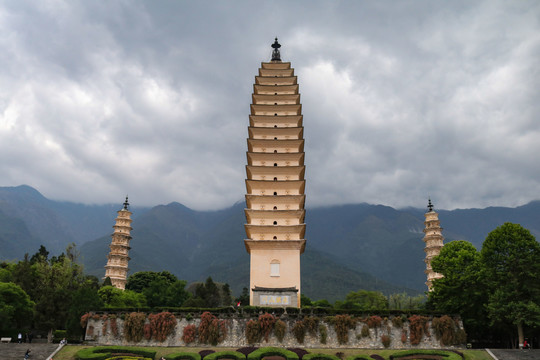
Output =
[{"x1": 0, "y1": 0, "x2": 540, "y2": 210}]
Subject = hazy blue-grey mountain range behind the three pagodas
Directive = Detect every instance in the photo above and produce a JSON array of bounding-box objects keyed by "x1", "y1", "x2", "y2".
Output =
[{"x1": 0, "y1": 185, "x2": 540, "y2": 301}]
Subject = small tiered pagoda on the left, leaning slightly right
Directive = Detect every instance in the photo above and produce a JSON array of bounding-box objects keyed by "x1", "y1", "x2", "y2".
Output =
[{"x1": 103, "y1": 196, "x2": 132, "y2": 290}]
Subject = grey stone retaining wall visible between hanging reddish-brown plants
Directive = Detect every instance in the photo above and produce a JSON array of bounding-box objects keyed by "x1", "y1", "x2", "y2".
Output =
[{"x1": 85, "y1": 313, "x2": 463, "y2": 349}]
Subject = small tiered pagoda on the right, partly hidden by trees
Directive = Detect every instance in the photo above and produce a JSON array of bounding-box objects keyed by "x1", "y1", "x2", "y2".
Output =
[{"x1": 424, "y1": 199, "x2": 444, "y2": 291}]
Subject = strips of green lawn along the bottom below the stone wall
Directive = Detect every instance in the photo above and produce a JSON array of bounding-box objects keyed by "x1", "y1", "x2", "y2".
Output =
[{"x1": 54, "y1": 345, "x2": 492, "y2": 360}]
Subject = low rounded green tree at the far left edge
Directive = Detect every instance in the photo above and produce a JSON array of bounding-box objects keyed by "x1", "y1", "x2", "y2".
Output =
[{"x1": 0, "y1": 282, "x2": 35, "y2": 330}]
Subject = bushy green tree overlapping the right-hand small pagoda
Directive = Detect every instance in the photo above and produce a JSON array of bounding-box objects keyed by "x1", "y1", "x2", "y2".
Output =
[{"x1": 428, "y1": 240, "x2": 487, "y2": 337}]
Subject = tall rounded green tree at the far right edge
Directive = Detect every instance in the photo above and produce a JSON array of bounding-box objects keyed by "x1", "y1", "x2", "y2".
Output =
[{"x1": 480, "y1": 223, "x2": 540, "y2": 346}]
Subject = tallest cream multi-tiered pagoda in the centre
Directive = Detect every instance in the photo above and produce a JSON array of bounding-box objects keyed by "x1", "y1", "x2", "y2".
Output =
[{"x1": 244, "y1": 38, "x2": 306, "y2": 307}]
